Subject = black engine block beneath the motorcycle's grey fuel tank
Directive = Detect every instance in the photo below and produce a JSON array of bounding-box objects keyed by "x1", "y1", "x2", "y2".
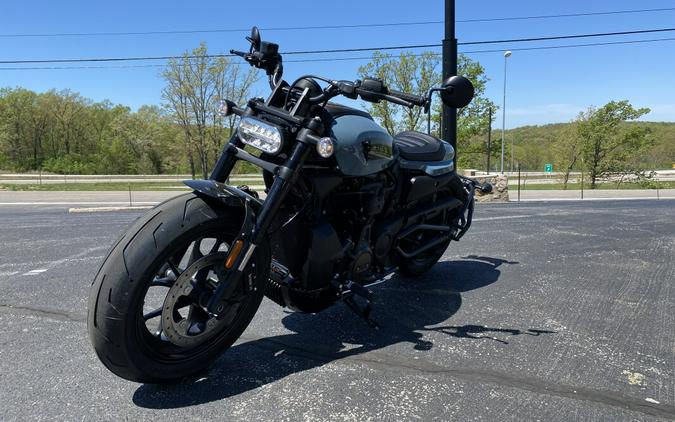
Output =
[{"x1": 272, "y1": 172, "x2": 396, "y2": 290}]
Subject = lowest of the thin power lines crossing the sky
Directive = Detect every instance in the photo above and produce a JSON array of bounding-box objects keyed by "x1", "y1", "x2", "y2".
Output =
[{"x1": 0, "y1": 37, "x2": 675, "y2": 71}]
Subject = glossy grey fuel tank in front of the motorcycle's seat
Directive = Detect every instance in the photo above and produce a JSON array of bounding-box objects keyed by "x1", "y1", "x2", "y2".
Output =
[{"x1": 330, "y1": 112, "x2": 394, "y2": 176}]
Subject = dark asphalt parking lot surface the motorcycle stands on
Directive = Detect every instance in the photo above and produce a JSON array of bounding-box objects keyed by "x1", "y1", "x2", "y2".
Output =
[{"x1": 0, "y1": 200, "x2": 675, "y2": 421}]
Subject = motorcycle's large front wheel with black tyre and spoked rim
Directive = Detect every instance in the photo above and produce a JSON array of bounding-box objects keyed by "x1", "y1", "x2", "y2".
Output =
[{"x1": 87, "y1": 194, "x2": 270, "y2": 383}]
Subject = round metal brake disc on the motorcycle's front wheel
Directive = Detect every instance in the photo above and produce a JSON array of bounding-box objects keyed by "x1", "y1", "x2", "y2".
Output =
[{"x1": 162, "y1": 252, "x2": 240, "y2": 348}]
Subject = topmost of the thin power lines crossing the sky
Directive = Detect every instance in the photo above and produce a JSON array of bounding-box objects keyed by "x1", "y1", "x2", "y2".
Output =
[{"x1": 0, "y1": 7, "x2": 675, "y2": 38}]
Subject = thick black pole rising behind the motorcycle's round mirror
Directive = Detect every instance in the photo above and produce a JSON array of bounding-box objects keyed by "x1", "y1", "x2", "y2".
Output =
[{"x1": 441, "y1": 0, "x2": 457, "y2": 166}]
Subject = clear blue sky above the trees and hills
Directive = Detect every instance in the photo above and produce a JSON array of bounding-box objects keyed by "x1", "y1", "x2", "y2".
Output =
[{"x1": 0, "y1": 0, "x2": 675, "y2": 127}]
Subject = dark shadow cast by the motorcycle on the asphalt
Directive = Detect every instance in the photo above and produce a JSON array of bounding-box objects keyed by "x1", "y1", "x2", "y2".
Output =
[{"x1": 133, "y1": 255, "x2": 524, "y2": 409}]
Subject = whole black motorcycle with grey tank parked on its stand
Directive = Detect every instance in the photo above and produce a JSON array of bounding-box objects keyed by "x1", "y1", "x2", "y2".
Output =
[{"x1": 87, "y1": 27, "x2": 490, "y2": 383}]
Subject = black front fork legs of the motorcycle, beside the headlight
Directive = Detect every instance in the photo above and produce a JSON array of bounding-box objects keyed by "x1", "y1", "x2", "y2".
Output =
[{"x1": 206, "y1": 135, "x2": 311, "y2": 315}]
